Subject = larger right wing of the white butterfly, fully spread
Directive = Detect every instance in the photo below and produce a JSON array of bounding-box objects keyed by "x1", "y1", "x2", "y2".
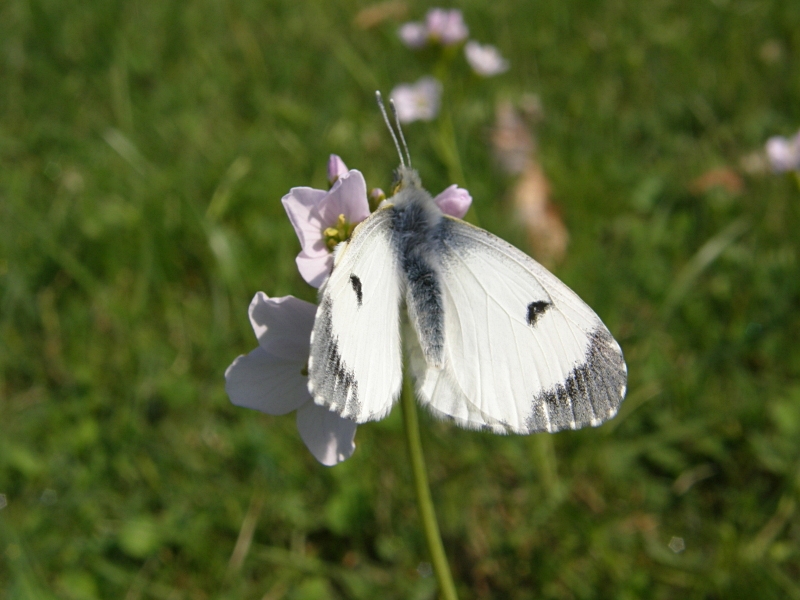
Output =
[{"x1": 412, "y1": 217, "x2": 627, "y2": 433}]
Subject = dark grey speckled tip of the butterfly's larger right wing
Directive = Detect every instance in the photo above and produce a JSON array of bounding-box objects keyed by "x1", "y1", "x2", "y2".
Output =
[{"x1": 526, "y1": 327, "x2": 627, "y2": 433}]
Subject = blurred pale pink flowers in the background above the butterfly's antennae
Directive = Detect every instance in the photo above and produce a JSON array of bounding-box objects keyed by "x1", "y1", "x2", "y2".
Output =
[{"x1": 390, "y1": 8, "x2": 509, "y2": 123}]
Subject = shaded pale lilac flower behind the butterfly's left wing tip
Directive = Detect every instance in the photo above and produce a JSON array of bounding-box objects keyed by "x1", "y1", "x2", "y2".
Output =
[{"x1": 225, "y1": 292, "x2": 356, "y2": 466}]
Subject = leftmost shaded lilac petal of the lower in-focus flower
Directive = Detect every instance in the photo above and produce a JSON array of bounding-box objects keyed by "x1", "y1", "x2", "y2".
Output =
[{"x1": 225, "y1": 346, "x2": 314, "y2": 415}]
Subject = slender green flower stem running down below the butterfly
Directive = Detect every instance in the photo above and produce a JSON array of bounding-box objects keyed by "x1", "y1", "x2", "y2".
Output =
[{"x1": 402, "y1": 377, "x2": 458, "y2": 600}]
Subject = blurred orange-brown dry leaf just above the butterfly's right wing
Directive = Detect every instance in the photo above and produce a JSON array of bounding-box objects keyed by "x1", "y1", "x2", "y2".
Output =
[{"x1": 512, "y1": 160, "x2": 569, "y2": 266}]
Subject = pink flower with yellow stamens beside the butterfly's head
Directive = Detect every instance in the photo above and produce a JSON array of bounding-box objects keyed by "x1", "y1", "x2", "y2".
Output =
[{"x1": 281, "y1": 164, "x2": 369, "y2": 288}]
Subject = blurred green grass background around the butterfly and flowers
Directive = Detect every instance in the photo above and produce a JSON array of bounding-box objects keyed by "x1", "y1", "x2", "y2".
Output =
[{"x1": 0, "y1": 0, "x2": 800, "y2": 600}]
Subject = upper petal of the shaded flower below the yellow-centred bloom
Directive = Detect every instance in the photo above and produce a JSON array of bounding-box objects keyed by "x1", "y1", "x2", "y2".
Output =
[{"x1": 249, "y1": 292, "x2": 317, "y2": 358}]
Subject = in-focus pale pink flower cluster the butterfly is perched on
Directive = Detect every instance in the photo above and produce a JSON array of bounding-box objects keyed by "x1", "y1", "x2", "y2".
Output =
[{"x1": 225, "y1": 154, "x2": 472, "y2": 466}]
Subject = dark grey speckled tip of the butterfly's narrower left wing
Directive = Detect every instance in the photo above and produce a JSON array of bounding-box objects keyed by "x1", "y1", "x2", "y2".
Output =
[{"x1": 308, "y1": 298, "x2": 361, "y2": 416}]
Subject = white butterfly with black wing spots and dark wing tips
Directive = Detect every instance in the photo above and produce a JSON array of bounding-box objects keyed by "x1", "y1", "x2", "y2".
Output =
[{"x1": 308, "y1": 95, "x2": 627, "y2": 434}]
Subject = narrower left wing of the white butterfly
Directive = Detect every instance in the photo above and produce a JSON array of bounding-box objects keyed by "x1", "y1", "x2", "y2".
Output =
[{"x1": 308, "y1": 210, "x2": 402, "y2": 423}]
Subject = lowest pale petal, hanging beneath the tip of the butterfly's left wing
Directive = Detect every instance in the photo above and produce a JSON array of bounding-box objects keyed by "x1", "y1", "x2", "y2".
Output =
[{"x1": 297, "y1": 402, "x2": 356, "y2": 467}]
